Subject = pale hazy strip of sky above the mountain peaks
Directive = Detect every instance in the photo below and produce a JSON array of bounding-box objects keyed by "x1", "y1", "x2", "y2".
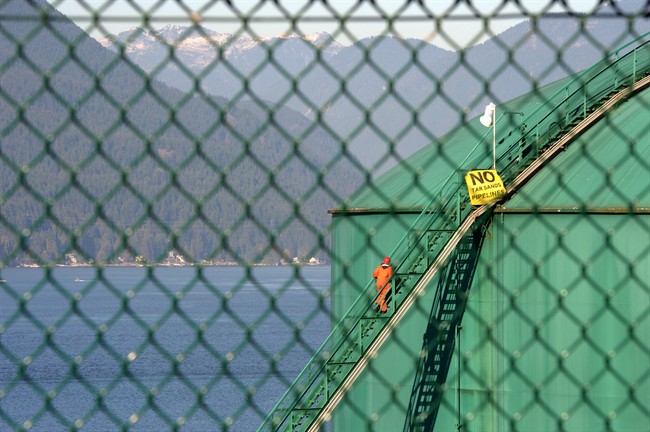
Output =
[{"x1": 49, "y1": 0, "x2": 599, "y2": 49}]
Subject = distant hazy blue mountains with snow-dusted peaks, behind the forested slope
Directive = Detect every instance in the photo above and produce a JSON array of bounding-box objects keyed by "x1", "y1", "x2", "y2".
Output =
[{"x1": 101, "y1": 0, "x2": 650, "y2": 166}]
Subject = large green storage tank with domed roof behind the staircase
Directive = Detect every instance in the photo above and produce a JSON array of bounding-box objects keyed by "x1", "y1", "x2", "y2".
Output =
[{"x1": 329, "y1": 66, "x2": 650, "y2": 432}]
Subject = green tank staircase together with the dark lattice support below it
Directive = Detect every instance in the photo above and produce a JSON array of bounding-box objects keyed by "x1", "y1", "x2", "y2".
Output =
[{"x1": 258, "y1": 33, "x2": 650, "y2": 432}]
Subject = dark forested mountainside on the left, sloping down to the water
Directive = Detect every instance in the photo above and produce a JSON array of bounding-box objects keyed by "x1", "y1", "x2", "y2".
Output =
[{"x1": 0, "y1": 1, "x2": 363, "y2": 265}]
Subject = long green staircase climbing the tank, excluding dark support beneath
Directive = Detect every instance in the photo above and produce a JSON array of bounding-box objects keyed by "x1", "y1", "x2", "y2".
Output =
[{"x1": 258, "y1": 33, "x2": 650, "y2": 432}]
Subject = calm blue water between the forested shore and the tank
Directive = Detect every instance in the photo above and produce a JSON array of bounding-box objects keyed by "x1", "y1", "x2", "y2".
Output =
[{"x1": 0, "y1": 266, "x2": 330, "y2": 432}]
